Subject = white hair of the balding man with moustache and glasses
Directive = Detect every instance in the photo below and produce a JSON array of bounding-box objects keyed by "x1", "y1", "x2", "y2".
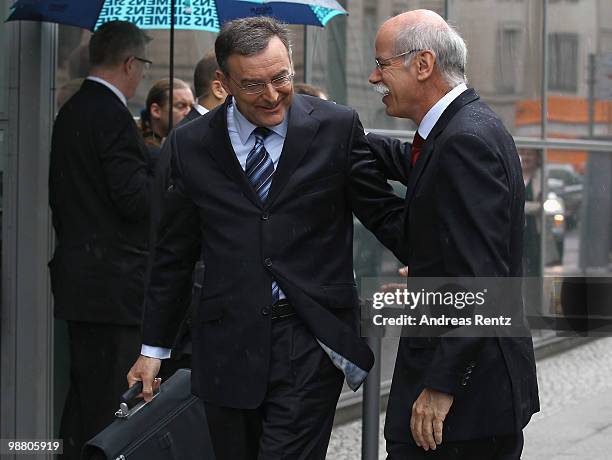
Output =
[{"x1": 395, "y1": 23, "x2": 467, "y2": 88}]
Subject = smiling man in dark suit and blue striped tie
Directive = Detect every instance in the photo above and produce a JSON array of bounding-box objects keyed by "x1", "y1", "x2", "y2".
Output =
[{"x1": 128, "y1": 17, "x2": 403, "y2": 460}]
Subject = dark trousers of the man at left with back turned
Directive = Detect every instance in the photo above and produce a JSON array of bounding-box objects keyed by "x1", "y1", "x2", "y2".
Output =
[{"x1": 59, "y1": 321, "x2": 141, "y2": 460}]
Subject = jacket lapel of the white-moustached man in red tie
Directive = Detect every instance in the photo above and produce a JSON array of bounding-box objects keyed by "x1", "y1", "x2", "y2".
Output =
[{"x1": 406, "y1": 88, "x2": 479, "y2": 205}]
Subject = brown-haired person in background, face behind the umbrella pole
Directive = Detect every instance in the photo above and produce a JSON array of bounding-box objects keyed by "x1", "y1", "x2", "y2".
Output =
[{"x1": 140, "y1": 78, "x2": 194, "y2": 158}]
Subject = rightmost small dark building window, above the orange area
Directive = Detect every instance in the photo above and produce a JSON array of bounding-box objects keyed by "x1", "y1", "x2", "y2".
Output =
[{"x1": 548, "y1": 33, "x2": 578, "y2": 93}]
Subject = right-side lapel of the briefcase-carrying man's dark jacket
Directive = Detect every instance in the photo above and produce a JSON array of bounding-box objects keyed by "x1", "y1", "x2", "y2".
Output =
[{"x1": 265, "y1": 94, "x2": 319, "y2": 208}]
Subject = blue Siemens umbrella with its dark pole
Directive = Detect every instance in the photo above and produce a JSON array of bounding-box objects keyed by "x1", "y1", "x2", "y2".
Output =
[{"x1": 7, "y1": 0, "x2": 348, "y2": 128}]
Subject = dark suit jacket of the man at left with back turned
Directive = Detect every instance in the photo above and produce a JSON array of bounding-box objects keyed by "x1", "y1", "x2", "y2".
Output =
[{"x1": 49, "y1": 80, "x2": 152, "y2": 325}]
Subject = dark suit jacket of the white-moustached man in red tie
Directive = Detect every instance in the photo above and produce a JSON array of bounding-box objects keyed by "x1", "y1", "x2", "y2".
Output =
[{"x1": 368, "y1": 89, "x2": 539, "y2": 442}]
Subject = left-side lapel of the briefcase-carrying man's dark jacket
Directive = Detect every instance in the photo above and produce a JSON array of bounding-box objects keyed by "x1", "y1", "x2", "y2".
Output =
[{"x1": 202, "y1": 98, "x2": 263, "y2": 208}]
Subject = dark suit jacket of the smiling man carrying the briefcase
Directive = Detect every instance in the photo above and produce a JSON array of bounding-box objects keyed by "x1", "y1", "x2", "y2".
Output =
[{"x1": 143, "y1": 95, "x2": 403, "y2": 408}]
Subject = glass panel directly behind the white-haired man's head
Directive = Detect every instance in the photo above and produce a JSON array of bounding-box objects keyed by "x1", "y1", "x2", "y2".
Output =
[{"x1": 448, "y1": 0, "x2": 542, "y2": 137}]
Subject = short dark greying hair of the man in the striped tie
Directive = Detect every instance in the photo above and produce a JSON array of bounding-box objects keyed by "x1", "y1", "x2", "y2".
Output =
[{"x1": 215, "y1": 16, "x2": 291, "y2": 75}]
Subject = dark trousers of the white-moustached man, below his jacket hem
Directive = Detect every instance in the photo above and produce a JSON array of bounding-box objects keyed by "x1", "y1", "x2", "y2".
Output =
[{"x1": 387, "y1": 434, "x2": 523, "y2": 460}]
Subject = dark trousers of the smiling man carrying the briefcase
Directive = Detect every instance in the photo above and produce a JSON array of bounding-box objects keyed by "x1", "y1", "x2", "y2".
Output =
[{"x1": 205, "y1": 316, "x2": 344, "y2": 460}]
